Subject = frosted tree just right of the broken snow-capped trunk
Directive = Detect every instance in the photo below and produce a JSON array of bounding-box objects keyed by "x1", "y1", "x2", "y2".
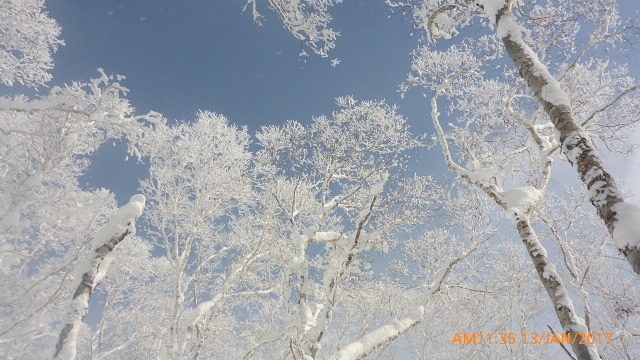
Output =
[{"x1": 136, "y1": 112, "x2": 261, "y2": 359}]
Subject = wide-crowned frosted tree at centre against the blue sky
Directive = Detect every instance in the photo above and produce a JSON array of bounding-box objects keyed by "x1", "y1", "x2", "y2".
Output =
[{"x1": 249, "y1": 97, "x2": 437, "y2": 358}]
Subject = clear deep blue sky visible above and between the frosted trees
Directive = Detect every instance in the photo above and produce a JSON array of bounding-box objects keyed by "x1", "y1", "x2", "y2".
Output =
[{"x1": 20, "y1": 0, "x2": 640, "y2": 204}]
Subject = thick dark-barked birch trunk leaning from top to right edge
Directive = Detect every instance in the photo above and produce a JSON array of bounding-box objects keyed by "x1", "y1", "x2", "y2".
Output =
[{"x1": 496, "y1": 2, "x2": 640, "y2": 274}]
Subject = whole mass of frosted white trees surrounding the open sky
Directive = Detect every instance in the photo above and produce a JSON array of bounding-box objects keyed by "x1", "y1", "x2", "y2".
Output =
[{"x1": 0, "y1": 0, "x2": 640, "y2": 360}]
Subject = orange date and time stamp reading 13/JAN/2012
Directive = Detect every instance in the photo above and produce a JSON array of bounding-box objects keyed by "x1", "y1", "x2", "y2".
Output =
[{"x1": 451, "y1": 332, "x2": 613, "y2": 345}]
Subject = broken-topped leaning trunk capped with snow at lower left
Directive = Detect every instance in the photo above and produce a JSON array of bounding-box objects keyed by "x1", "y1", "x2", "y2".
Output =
[{"x1": 54, "y1": 195, "x2": 145, "y2": 360}]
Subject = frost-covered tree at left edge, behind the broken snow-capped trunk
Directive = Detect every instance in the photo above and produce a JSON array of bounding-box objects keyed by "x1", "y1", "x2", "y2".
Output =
[{"x1": 0, "y1": 73, "x2": 157, "y2": 357}]
